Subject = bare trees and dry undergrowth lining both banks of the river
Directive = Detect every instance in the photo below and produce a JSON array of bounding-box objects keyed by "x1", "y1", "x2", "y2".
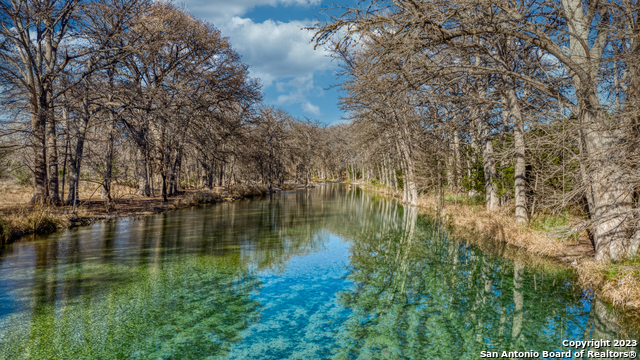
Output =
[{"x1": 0, "y1": 0, "x2": 640, "y2": 318}]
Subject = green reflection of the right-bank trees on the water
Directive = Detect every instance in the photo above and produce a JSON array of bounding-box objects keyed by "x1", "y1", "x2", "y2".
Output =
[{"x1": 335, "y1": 205, "x2": 635, "y2": 359}]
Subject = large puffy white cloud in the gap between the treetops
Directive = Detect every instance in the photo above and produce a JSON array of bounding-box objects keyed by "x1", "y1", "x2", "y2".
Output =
[{"x1": 186, "y1": 0, "x2": 334, "y2": 115}]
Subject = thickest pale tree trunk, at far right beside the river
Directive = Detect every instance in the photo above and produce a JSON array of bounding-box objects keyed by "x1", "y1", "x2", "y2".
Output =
[{"x1": 562, "y1": 0, "x2": 640, "y2": 261}]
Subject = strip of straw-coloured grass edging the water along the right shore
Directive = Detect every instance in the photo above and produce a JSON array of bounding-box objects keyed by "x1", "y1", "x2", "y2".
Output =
[{"x1": 351, "y1": 183, "x2": 640, "y2": 321}]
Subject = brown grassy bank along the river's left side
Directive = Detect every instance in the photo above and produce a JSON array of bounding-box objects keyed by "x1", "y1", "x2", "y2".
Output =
[{"x1": 0, "y1": 184, "x2": 272, "y2": 245}]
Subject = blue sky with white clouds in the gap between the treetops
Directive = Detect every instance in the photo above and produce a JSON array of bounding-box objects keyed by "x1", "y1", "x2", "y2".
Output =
[{"x1": 185, "y1": 0, "x2": 355, "y2": 124}]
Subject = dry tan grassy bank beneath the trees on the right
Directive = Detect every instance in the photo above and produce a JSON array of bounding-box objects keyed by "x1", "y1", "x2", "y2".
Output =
[{"x1": 359, "y1": 185, "x2": 640, "y2": 318}]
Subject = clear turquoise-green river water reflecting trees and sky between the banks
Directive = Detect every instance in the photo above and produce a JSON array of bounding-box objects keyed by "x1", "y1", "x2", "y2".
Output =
[{"x1": 0, "y1": 185, "x2": 637, "y2": 360}]
